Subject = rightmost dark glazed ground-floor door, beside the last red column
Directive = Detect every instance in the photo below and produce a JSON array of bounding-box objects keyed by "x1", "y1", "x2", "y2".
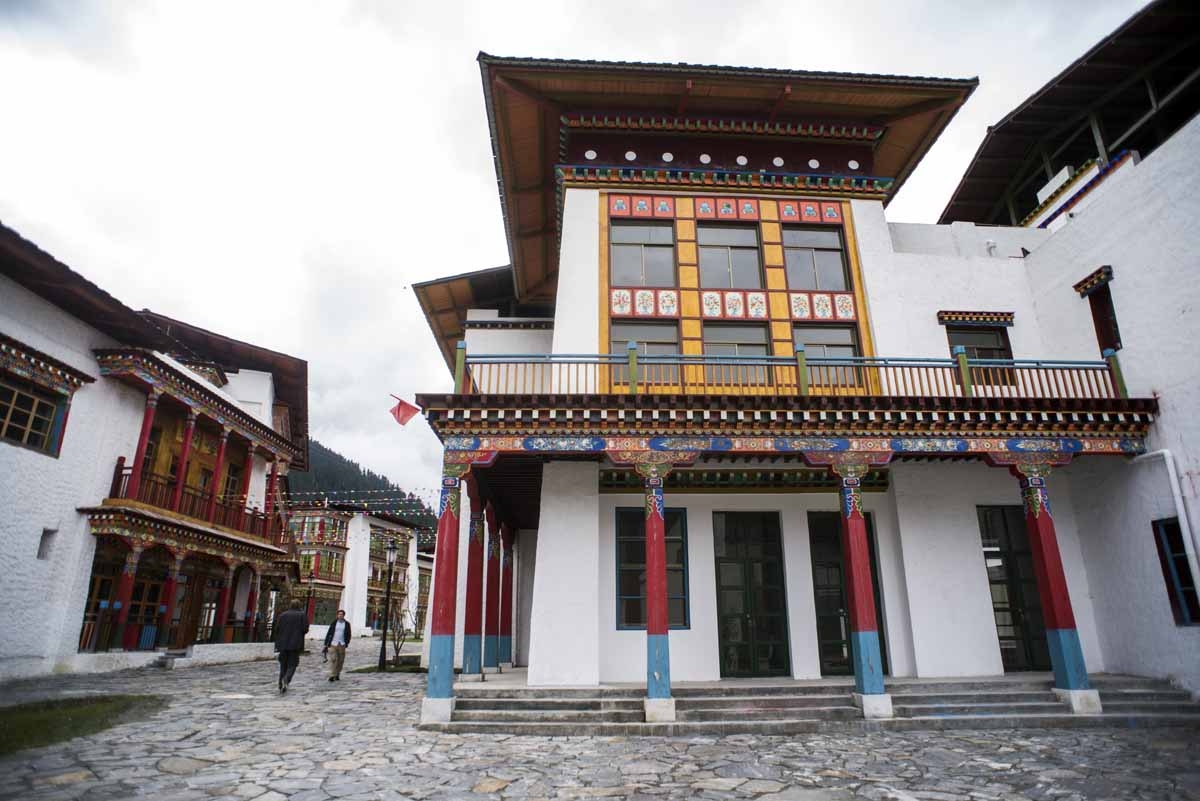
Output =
[{"x1": 978, "y1": 506, "x2": 1050, "y2": 673}]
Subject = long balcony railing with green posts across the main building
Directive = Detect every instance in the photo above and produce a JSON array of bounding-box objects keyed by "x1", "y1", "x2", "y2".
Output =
[{"x1": 455, "y1": 350, "x2": 1126, "y2": 399}]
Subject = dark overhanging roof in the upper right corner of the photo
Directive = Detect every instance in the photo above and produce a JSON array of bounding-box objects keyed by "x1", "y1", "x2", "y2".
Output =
[{"x1": 938, "y1": 0, "x2": 1200, "y2": 223}]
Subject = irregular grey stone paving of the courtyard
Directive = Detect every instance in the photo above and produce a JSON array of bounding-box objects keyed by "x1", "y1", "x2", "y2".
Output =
[{"x1": 0, "y1": 642, "x2": 1200, "y2": 801}]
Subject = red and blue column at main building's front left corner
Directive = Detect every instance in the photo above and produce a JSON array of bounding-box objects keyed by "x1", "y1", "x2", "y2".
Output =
[{"x1": 421, "y1": 464, "x2": 469, "y2": 723}]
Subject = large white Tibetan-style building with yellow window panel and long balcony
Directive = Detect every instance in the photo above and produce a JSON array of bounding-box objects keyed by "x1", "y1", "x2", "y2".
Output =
[{"x1": 415, "y1": 2, "x2": 1200, "y2": 730}]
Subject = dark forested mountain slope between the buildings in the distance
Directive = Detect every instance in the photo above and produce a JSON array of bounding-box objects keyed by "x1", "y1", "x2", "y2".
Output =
[{"x1": 288, "y1": 438, "x2": 436, "y2": 528}]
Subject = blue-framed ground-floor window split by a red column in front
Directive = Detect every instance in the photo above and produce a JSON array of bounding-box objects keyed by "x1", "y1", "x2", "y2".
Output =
[{"x1": 617, "y1": 508, "x2": 690, "y2": 628}]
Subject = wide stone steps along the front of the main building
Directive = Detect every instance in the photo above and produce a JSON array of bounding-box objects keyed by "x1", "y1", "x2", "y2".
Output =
[{"x1": 422, "y1": 675, "x2": 1200, "y2": 736}]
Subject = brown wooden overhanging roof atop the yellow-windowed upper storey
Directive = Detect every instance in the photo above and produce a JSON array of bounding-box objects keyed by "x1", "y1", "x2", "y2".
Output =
[{"x1": 479, "y1": 53, "x2": 978, "y2": 301}]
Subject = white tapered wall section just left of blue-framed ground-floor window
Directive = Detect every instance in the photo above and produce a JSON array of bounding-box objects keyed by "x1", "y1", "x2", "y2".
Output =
[{"x1": 529, "y1": 462, "x2": 597, "y2": 685}]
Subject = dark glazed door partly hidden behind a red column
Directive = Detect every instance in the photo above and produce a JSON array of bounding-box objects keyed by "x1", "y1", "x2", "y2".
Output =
[{"x1": 809, "y1": 512, "x2": 888, "y2": 676}]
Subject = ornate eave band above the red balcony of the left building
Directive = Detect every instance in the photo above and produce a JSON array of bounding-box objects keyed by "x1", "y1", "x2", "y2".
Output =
[{"x1": 95, "y1": 348, "x2": 296, "y2": 459}]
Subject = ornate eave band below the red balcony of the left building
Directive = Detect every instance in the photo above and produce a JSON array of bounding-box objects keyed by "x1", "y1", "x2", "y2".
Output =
[{"x1": 79, "y1": 506, "x2": 287, "y2": 573}]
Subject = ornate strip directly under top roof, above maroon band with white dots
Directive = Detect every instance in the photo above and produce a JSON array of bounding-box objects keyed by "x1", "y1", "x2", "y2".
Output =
[{"x1": 562, "y1": 112, "x2": 886, "y2": 143}]
